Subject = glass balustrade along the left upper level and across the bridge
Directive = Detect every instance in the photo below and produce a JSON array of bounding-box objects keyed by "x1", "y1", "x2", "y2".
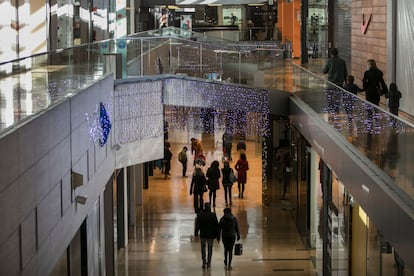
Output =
[{"x1": 0, "y1": 27, "x2": 283, "y2": 133}]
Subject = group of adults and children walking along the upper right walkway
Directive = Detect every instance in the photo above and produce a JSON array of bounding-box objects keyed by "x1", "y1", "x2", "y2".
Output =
[{"x1": 322, "y1": 48, "x2": 401, "y2": 116}]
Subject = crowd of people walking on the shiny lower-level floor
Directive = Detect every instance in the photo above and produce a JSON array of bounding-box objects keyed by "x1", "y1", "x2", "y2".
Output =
[{"x1": 164, "y1": 135, "x2": 249, "y2": 270}]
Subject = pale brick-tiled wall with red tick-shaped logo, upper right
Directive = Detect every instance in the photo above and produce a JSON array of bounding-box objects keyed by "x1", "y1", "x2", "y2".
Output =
[{"x1": 351, "y1": 0, "x2": 388, "y2": 85}]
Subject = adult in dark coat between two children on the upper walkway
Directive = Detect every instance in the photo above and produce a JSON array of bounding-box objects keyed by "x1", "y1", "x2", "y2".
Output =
[{"x1": 362, "y1": 59, "x2": 388, "y2": 105}]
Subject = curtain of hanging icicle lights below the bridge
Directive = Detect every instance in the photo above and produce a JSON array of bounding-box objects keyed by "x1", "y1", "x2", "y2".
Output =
[{"x1": 114, "y1": 78, "x2": 269, "y2": 144}]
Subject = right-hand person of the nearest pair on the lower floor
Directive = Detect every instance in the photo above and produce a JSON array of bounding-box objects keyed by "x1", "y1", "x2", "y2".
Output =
[{"x1": 217, "y1": 208, "x2": 240, "y2": 270}]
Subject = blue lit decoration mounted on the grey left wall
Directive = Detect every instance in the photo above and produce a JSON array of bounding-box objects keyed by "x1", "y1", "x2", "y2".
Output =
[{"x1": 85, "y1": 102, "x2": 112, "y2": 147}]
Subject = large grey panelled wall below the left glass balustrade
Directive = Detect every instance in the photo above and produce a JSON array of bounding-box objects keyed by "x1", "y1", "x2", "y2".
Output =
[{"x1": 0, "y1": 76, "x2": 115, "y2": 275}]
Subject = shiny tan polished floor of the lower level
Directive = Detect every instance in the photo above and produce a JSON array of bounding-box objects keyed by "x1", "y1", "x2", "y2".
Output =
[{"x1": 117, "y1": 128, "x2": 316, "y2": 275}]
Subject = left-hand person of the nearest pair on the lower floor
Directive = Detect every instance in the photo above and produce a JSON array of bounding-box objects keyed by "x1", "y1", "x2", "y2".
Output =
[{"x1": 195, "y1": 203, "x2": 219, "y2": 269}]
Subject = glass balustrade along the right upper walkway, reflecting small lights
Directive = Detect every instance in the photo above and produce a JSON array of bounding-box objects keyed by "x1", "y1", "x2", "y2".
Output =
[{"x1": 293, "y1": 65, "x2": 414, "y2": 205}]
